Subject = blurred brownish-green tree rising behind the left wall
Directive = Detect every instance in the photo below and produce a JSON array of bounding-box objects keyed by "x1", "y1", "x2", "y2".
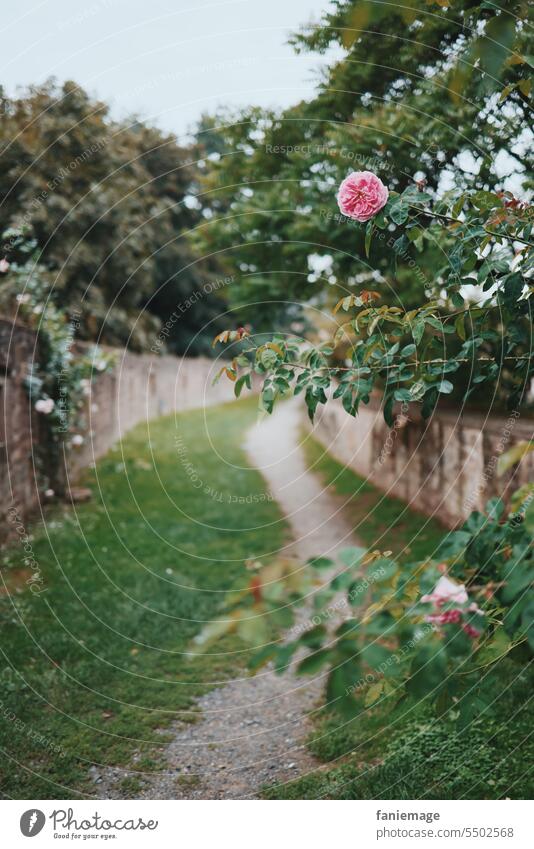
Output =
[{"x1": 0, "y1": 82, "x2": 225, "y2": 353}]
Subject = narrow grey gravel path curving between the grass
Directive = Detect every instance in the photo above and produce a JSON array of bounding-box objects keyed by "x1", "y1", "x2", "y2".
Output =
[{"x1": 98, "y1": 401, "x2": 357, "y2": 799}]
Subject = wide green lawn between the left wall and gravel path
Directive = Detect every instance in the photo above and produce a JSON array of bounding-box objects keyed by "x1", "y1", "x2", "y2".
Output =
[{"x1": 0, "y1": 398, "x2": 287, "y2": 799}]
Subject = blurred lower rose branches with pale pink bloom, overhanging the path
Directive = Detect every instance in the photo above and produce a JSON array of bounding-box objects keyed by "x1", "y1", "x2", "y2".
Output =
[{"x1": 196, "y1": 484, "x2": 534, "y2": 723}]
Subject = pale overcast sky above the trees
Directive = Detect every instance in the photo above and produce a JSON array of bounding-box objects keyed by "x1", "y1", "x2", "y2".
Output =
[{"x1": 0, "y1": 0, "x2": 338, "y2": 135}]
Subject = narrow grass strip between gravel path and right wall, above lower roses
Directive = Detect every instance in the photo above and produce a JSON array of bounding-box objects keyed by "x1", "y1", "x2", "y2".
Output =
[{"x1": 302, "y1": 434, "x2": 446, "y2": 562}]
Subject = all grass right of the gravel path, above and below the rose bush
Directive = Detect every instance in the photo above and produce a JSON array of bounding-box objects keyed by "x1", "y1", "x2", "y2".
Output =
[{"x1": 263, "y1": 437, "x2": 534, "y2": 799}]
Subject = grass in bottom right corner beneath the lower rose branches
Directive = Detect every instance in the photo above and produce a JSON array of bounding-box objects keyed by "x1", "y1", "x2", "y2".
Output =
[{"x1": 263, "y1": 663, "x2": 534, "y2": 799}]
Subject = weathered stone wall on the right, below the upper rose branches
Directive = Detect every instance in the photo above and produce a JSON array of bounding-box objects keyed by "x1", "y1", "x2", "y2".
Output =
[{"x1": 314, "y1": 399, "x2": 534, "y2": 527}]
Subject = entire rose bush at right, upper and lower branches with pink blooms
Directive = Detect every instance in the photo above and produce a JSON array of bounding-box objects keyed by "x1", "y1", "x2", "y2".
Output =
[{"x1": 206, "y1": 166, "x2": 534, "y2": 722}]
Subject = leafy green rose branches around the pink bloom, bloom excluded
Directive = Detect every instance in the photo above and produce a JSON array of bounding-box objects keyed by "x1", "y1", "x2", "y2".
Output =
[{"x1": 216, "y1": 182, "x2": 534, "y2": 426}]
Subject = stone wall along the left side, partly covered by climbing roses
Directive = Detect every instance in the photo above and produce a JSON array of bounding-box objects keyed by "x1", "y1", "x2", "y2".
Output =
[{"x1": 0, "y1": 318, "x2": 233, "y2": 539}]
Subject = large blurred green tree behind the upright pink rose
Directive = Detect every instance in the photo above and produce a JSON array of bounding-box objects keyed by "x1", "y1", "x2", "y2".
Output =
[{"x1": 202, "y1": 0, "x2": 534, "y2": 408}]
